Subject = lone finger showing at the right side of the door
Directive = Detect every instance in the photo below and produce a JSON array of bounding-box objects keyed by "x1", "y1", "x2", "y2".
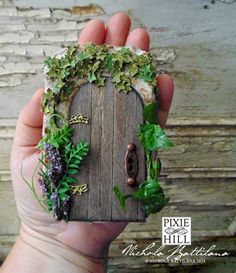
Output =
[{"x1": 156, "y1": 74, "x2": 174, "y2": 128}]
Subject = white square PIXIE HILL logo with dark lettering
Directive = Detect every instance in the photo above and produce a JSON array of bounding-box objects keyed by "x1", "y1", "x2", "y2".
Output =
[{"x1": 162, "y1": 217, "x2": 191, "y2": 245}]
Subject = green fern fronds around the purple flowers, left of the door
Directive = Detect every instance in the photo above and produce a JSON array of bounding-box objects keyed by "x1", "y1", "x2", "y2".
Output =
[{"x1": 37, "y1": 115, "x2": 89, "y2": 221}]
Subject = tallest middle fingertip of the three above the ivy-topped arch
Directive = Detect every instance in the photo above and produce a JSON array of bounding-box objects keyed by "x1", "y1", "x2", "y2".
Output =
[{"x1": 105, "y1": 13, "x2": 131, "y2": 46}]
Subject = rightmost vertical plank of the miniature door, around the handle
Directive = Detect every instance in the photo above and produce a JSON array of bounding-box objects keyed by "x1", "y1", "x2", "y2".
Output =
[{"x1": 113, "y1": 87, "x2": 145, "y2": 221}]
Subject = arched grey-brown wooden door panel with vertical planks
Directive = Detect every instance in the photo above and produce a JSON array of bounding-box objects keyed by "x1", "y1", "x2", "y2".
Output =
[{"x1": 69, "y1": 78, "x2": 145, "y2": 221}]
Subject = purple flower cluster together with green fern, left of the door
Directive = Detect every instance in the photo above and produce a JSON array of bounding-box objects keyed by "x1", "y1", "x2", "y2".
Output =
[{"x1": 37, "y1": 118, "x2": 89, "y2": 222}]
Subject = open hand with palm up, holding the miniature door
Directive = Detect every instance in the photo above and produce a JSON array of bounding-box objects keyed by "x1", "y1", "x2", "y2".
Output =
[{"x1": 6, "y1": 13, "x2": 173, "y2": 270}]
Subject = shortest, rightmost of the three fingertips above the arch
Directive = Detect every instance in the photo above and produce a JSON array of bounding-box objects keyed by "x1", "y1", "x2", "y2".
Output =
[{"x1": 126, "y1": 28, "x2": 150, "y2": 51}]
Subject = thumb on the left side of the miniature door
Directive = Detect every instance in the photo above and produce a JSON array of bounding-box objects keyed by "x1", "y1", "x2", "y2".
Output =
[{"x1": 14, "y1": 89, "x2": 44, "y2": 148}]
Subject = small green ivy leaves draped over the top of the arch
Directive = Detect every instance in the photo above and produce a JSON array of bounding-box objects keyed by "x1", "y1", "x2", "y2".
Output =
[{"x1": 42, "y1": 43, "x2": 155, "y2": 114}]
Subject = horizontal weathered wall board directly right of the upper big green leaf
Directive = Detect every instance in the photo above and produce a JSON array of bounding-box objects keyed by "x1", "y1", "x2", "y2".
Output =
[{"x1": 160, "y1": 136, "x2": 236, "y2": 177}]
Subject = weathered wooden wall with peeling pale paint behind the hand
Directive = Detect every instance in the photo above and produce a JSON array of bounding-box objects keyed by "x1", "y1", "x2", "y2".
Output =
[{"x1": 0, "y1": 0, "x2": 236, "y2": 273}]
